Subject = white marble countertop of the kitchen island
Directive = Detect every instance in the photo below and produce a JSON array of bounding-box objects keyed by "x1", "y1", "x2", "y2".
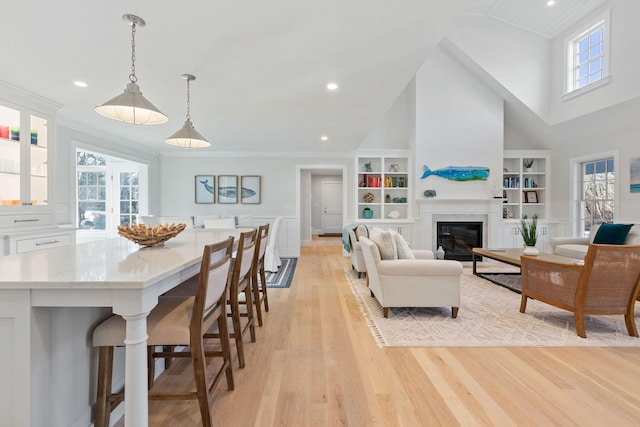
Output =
[{"x1": 0, "y1": 229, "x2": 240, "y2": 289}]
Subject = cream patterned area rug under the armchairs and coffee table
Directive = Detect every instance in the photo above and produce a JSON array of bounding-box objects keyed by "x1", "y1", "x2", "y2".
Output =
[{"x1": 345, "y1": 268, "x2": 640, "y2": 347}]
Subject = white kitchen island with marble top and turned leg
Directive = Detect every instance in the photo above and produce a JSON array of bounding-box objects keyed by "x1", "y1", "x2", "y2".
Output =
[{"x1": 0, "y1": 229, "x2": 240, "y2": 427}]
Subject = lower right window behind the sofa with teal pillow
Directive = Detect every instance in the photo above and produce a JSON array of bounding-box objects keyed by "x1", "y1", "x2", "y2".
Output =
[{"x1": 580, "y1": 158, "x2": 615, "y2": 236}]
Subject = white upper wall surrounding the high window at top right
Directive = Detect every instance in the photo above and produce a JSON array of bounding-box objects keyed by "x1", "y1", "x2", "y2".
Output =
[{"x1": 550, "y1": 0, "x2": 640, "y2": 124}]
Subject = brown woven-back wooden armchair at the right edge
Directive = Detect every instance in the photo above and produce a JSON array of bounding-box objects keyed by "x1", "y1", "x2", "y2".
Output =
[{"x1": 520, "y1": 244, "x2": 640, "y2": 338}]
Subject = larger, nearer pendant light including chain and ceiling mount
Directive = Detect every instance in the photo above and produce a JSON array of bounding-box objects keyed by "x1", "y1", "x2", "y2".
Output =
[{"x1": 96, "y1": 14, "x2": 169, "y2": 125}]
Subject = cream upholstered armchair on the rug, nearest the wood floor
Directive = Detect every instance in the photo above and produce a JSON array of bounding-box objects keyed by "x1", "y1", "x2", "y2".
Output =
[{"x1": 359, "y1": 237, "x2": 462, "y2": 318}]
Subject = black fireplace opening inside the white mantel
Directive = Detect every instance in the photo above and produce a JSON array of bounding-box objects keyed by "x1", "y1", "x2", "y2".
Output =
[{"x1": 436, "y1": 221, "x2": 482, "y2": 261}]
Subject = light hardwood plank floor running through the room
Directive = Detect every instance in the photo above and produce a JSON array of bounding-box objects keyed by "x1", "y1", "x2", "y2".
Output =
[{"x1": 125, "y1": 239, "x2": 640, "y2": 427}]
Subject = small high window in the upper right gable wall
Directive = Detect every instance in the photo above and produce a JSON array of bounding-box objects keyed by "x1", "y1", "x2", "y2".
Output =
[{"x1": 565, "y1": 10, "x2": 609, "y2": 95}]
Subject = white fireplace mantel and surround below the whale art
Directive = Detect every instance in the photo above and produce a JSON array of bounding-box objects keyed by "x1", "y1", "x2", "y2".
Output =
[{"x1": 418, "y1": 197, "x2": 502, "y2": 250}]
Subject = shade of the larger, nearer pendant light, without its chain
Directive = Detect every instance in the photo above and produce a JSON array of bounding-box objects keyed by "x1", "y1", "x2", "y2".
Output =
[{"x1": 96, "y1": 83, "x2": 169, "y2": 125}]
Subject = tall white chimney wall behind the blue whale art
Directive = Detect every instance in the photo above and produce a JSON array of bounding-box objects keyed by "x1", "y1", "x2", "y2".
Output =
[{"x1": 414, "y1": 48, "x2": 503, "y2": 204}]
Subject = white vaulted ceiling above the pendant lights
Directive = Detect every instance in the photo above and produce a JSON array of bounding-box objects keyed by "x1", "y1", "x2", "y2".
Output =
[{"x1": 0, "y1": 0, "x2": 604, "y2": 152}]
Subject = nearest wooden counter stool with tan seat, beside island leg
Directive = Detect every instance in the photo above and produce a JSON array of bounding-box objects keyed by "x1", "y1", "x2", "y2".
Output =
[{"x1": 93, "y1": 237, "x2": 234, "y2": 427}]
